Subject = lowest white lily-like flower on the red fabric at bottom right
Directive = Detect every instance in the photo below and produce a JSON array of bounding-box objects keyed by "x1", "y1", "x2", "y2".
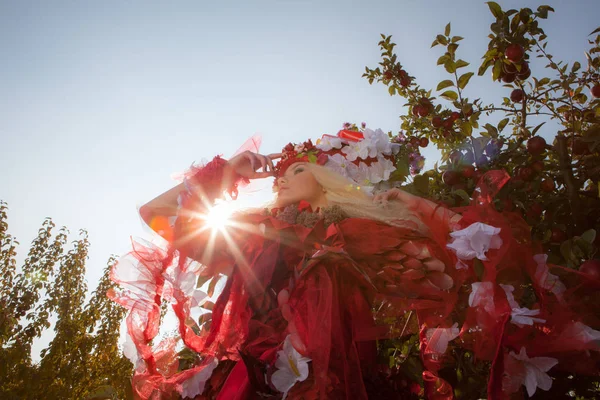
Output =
[{"x1": 503, "y1": 347, "x2": 558, "y2": 397}]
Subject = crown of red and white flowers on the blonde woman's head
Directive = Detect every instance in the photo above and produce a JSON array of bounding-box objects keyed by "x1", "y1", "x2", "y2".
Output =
[{"x1": 275, "y1": 128, "x2": 400, "y2": 190}]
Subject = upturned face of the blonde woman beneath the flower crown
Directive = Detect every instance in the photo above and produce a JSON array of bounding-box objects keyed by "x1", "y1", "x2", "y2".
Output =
[{"x1": 277, "y1": 163, "x2": 327, "y2": 209}]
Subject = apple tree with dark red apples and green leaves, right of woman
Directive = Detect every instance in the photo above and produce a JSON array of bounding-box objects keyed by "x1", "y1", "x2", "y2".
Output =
[{"x1": 363, "y1": 2, "x2": 600, "y2": 398}]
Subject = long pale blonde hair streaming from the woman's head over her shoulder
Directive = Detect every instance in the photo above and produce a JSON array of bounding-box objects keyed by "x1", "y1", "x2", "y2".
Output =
[{"x1": 284, "y1": 163, "x2": 429, "y2": 235}]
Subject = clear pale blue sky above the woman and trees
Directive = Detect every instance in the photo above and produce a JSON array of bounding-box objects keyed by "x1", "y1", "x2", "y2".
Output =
[{"x1": 0, "y1": 0, "x2": 600, "y2": 348}]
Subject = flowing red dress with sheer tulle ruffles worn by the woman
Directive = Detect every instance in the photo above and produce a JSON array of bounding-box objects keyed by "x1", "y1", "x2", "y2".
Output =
[{"x1": 111, "y1": 160, "x2": 598, "y2": 399}]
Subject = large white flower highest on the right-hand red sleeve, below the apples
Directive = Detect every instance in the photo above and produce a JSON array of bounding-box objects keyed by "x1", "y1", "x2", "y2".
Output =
[{"x1": 446, "y1": 222, "x2": 502, "y2": 269}]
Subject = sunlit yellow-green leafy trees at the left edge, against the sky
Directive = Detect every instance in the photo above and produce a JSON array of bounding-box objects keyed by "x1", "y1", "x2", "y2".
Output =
[{"x1": 0, "y1": 202, "x2": 132, "y2": 399}]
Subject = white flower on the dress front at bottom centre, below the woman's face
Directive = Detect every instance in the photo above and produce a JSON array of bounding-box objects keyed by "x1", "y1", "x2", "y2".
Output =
[{"x1": 271, "y1": 335, "x2": 311, "y2": 399}]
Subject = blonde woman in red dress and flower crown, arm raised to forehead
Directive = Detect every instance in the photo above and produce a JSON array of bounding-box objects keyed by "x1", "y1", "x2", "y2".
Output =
[{"x1": 111, "y1": 130, "x2": 599, "y2": 399}]
